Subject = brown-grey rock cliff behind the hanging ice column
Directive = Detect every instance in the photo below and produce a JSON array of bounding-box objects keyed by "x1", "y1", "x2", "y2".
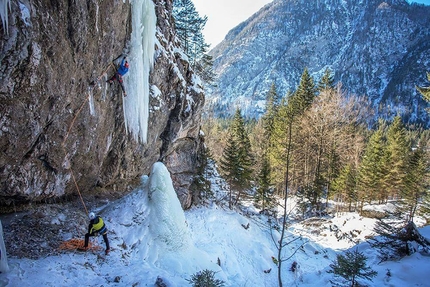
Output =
[{"x1": 0, "y1": 0, "x2": 204, "y2": 208}]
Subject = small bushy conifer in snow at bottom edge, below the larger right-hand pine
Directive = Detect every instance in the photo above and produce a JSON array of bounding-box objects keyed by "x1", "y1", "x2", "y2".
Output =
[{"x1": 328, "y1": 249, "x2": 378, "y2": 287}]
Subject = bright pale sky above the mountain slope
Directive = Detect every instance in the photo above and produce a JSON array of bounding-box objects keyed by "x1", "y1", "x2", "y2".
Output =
[{"x1": 193, "y1": 0, "x2": 430, "y2": 49}]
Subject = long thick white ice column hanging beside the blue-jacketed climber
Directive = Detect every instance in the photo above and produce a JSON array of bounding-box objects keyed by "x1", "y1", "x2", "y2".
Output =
[{"x1": 123, "y1": 0, "x2": 157, "y2": 143}]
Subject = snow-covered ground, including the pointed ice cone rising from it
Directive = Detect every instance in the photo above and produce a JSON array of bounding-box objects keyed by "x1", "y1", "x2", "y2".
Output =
[{"x1": 0, "y1": 163, "x2": 430, "y2": 287}]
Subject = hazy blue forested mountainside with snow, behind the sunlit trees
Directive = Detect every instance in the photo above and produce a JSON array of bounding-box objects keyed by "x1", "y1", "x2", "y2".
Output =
[{"x1": 207, "y1": 0, "x2": 430, "y2": 123}]
